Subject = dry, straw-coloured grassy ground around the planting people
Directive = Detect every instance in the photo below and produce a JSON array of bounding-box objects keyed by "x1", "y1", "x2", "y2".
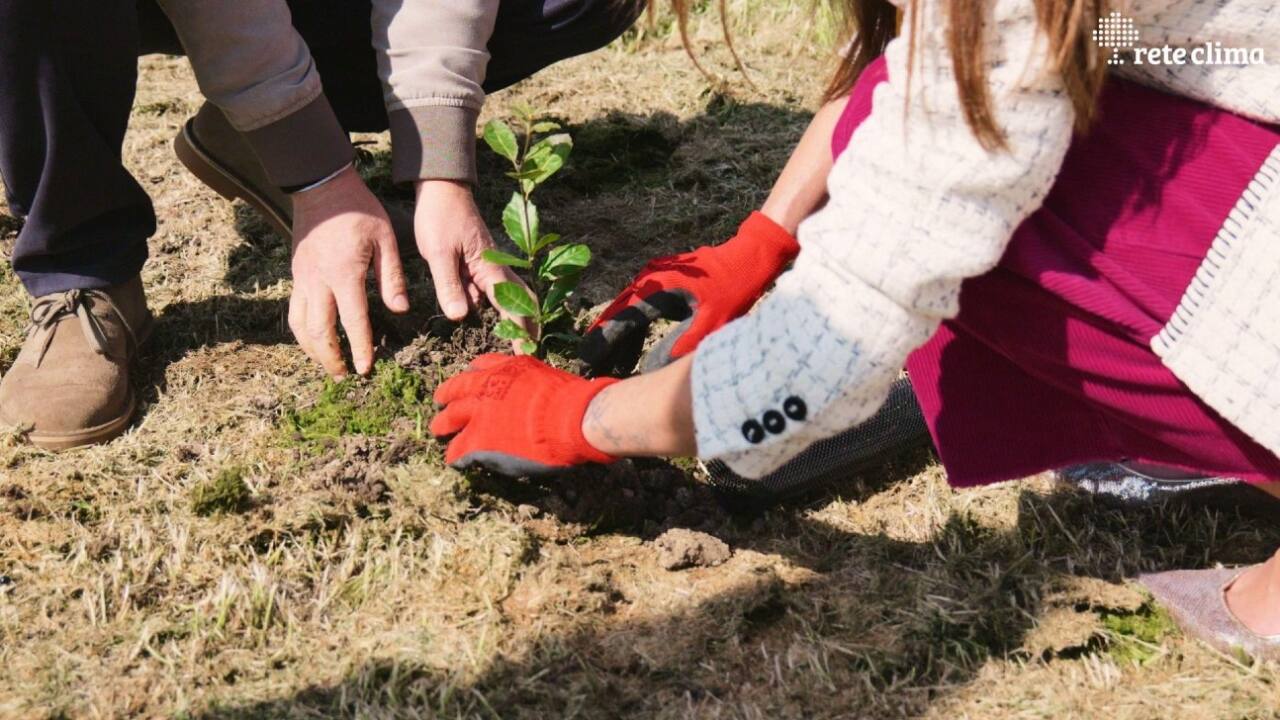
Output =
[{"x1": 0, "y1": 0, "x2": 1280, "y2": 719}]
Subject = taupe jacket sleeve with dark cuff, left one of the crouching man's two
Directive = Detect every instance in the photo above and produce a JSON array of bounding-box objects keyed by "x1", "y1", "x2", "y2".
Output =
[{"x1": 160, "y1": 0, "x2": 353, "y2": 187}]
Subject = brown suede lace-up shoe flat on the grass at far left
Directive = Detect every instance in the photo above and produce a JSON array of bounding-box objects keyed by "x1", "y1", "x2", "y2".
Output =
[{"x1": 0, "y1": 278, "x2": 154, "y2": 450}]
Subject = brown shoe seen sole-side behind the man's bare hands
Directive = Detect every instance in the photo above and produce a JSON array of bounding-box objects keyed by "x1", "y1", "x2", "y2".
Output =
[{"x1": 173, "y1": 102, "x2": 413, "y2": 247}]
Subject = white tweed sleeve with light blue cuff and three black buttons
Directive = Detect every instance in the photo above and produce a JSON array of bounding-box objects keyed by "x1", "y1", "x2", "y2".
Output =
[{"x1": 692, "y1": 0, "x2": 1074, "y2": 477}]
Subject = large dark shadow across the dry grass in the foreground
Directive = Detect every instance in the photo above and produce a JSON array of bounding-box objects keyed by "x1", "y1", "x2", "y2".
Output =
[{"x1": 186, "y1": 479, "x2": 1280, "y2": 720}]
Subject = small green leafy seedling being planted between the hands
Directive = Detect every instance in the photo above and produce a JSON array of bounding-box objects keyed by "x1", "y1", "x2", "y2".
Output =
[{"x1": 484, "y1": 108, "x2": 591, "y2": 355}]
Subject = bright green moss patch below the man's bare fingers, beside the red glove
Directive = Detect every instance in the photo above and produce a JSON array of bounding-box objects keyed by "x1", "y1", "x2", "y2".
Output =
[{"x1": 284, "y1": 360, "x2": 424, "y2": 443}]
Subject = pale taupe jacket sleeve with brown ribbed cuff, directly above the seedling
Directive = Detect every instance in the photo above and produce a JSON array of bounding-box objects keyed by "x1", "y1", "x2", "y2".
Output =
[{"x1": 372, "y1": 0, "x2": 499, "y2": 182}]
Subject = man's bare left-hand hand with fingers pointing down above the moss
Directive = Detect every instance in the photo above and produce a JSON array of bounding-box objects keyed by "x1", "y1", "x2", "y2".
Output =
[{"x1": 289, "y1": 161, "x2": 408, "y2": 379}]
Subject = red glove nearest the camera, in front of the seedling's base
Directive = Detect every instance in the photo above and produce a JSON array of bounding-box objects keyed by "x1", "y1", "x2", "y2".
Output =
[{"x1": 431, "y1": 355, "x2": 618, "y2": 477}]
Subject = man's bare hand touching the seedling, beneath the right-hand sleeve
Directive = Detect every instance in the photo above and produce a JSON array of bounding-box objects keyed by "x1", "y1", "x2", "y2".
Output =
[{"x1": 413, "y1": 181, "x2": 521, "y2": 320}]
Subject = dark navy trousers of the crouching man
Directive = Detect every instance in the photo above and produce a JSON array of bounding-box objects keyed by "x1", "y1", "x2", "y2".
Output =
[{"x1": 0, "y1": 0, "x2": 645, "y2": 296}]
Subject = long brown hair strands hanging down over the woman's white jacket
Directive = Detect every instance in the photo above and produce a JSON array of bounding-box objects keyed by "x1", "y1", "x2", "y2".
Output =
[{"x1": 649, "y1": 0, "x2": 1108, "y2": 150}]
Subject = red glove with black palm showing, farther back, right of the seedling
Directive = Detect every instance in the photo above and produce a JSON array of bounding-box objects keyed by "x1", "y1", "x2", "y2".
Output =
[{"x1": 579, "y1": 213, "x2": 800, "y2": 374}]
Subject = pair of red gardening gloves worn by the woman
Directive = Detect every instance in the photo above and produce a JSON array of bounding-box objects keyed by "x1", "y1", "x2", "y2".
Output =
[{"x1": 431, "y1": 213, "x2": 800, "y2": 475}]
